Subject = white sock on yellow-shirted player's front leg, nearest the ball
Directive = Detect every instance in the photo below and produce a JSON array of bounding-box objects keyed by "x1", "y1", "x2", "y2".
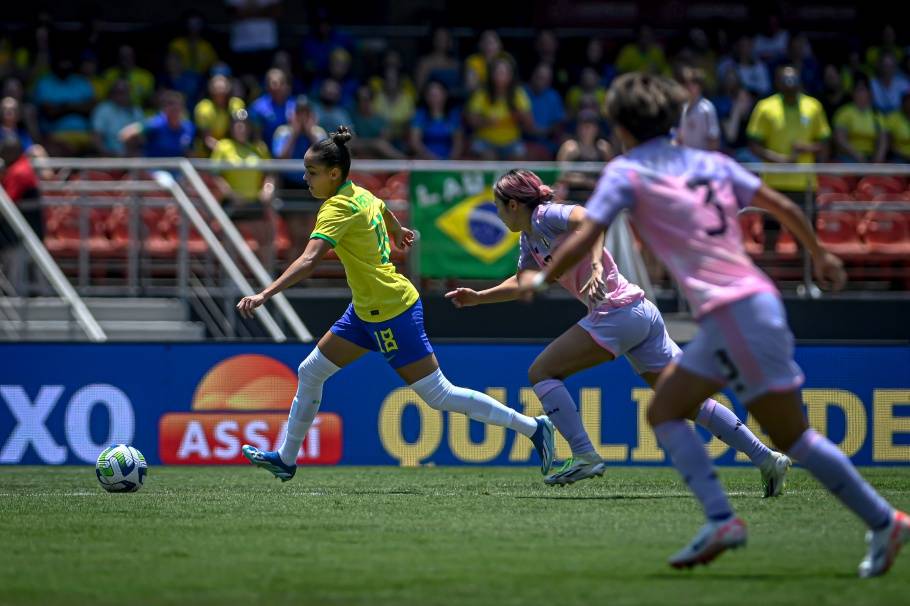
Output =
[{"x1": 278, "y1": 347, "x2": 339, "y2": 465}]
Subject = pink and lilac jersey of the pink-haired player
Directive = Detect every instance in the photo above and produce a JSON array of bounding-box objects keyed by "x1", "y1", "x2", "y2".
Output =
[{"x1": 518, "y1": 204, "x2": 645, "y2": 311}]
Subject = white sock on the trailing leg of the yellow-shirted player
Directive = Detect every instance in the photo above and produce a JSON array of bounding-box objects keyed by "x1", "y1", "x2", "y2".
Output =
[{"x1": 411, "y1": 368, "x2": 537, "y2": 437}]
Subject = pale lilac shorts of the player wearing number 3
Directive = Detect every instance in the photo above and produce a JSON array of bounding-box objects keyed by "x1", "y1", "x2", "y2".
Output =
[{"x1": 679, "y1": 293, "x2": 804, "y2": 404}]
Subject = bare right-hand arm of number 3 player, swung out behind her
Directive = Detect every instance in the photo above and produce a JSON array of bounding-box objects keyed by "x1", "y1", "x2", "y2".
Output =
[{"x1": 751, "y1": 184, "x2": 847, "y2": 290}]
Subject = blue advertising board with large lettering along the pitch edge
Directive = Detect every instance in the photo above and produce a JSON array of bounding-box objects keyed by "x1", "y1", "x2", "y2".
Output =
[{"x1": 0, "y1": 343, "x2": 910, "y2": 465}]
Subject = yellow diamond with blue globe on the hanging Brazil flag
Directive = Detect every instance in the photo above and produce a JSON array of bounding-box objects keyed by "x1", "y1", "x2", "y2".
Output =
[{"x1": 436, "y1": 187, "x2": 519, "y2": 263}]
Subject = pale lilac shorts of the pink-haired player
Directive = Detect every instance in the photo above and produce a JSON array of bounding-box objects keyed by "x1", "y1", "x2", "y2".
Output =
[{"x1": 578, "y1": 299, "x2": 681, "y2": 374}]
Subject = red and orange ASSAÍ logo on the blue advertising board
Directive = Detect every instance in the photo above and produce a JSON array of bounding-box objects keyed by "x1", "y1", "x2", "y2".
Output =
[{"x1": 158, "y1": 354, "x2": 341, "y2": 465}]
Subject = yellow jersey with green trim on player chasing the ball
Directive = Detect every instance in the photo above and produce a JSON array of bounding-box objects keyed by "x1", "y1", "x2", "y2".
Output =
[{"x1": 310, "y1": 181, "x2": 419, "y2": 322}]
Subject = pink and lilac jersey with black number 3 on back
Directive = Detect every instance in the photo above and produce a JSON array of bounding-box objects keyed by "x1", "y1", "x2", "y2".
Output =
[{"x1": 587, "y1": 139, "x2": 778, "y2": 318}]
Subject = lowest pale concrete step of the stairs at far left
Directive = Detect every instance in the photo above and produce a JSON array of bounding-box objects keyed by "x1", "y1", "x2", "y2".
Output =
[{"x1": 0, "y1": 320, "x2": 205, "y2": 341}]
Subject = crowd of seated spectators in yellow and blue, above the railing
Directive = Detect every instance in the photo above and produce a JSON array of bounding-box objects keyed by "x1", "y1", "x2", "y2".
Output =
[{"x1": 0, "y1": 12, "x2": 910, "y2": 173}]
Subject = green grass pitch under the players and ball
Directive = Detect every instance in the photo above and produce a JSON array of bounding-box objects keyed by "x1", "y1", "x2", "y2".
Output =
[{"x1": 0, "y1": 467, "x2": 910, "y2": 606}]
